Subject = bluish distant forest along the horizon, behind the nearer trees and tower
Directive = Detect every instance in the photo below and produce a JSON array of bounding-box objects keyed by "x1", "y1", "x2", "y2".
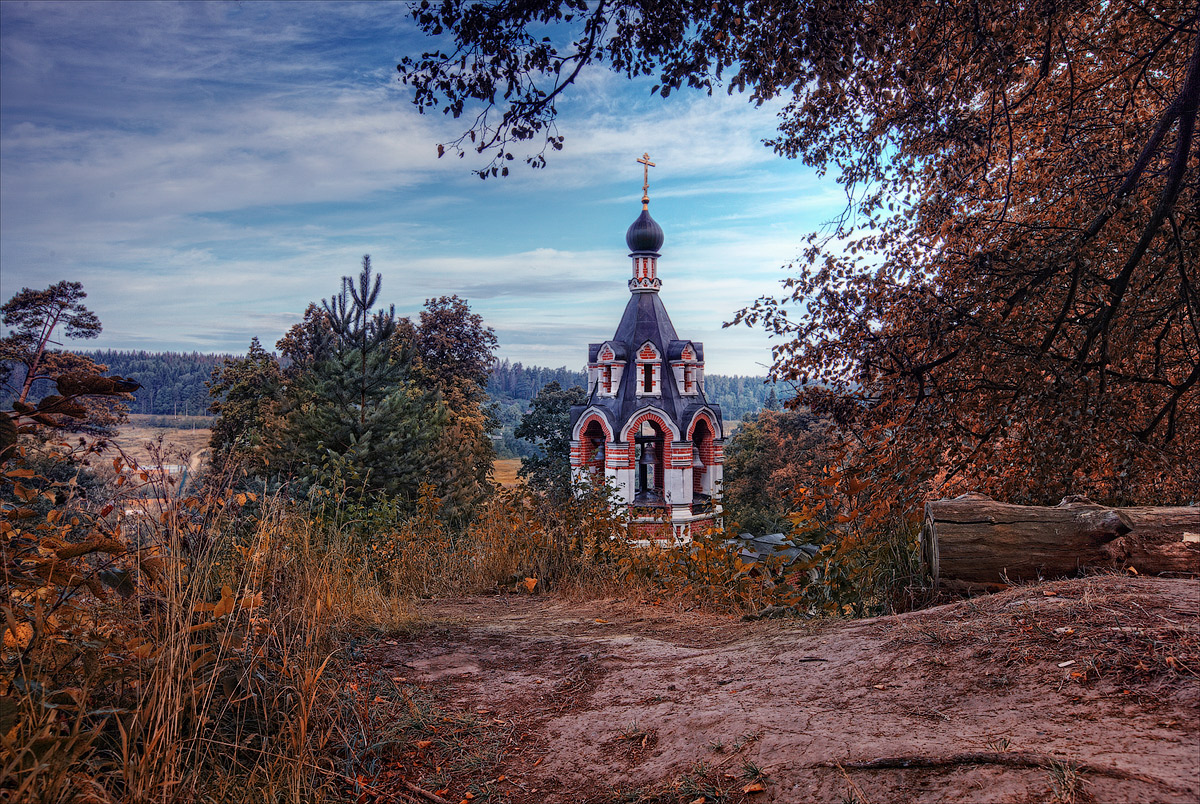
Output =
[{"x1": 4, "y1": 349, "x2": 791, "y2": 457}]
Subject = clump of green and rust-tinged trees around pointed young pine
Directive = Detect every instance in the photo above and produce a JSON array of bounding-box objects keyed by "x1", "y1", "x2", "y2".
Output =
[{"x1": 209, "y1": 261, "x2": 497, "y2": 526}]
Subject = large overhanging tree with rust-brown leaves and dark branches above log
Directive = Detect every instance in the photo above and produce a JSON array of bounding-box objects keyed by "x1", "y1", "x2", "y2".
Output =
[{"x1": 398, "y1": 0, "x2": 1200, "y2": 502}]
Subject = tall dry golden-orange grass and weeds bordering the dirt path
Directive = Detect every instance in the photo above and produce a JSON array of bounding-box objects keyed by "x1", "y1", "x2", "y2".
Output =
[{"x1": 0, "y1": 441, "x2": 916, "y2": 804}]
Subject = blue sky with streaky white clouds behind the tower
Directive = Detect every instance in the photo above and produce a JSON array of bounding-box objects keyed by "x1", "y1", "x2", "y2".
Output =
[{"x1": 0, "y1": 0, "x2": 845, "y2": 374}]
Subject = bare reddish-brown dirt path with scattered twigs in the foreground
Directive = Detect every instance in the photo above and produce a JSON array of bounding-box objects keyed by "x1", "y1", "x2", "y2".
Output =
[{"x1": 367, "y1": 576, "x2": 1200, "y2": 803}]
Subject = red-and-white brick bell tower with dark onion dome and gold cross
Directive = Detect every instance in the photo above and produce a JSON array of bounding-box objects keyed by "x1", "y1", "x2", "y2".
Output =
[{"x1": 571, "y1": 154, "x2": 725, "y2": 544}]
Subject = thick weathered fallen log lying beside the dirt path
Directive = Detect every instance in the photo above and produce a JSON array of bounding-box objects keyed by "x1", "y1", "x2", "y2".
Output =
[{"x1": 920, "y1": 493, "x2": 1200, "y2": 588}]
